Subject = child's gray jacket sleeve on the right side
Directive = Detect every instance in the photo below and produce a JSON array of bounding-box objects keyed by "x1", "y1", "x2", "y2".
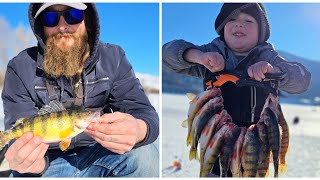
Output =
[{"x1": 263, "y1": 45, "x2": 311, "y2": 94}]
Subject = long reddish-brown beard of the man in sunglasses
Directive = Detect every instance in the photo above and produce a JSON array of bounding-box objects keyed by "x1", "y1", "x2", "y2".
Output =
[{"x1": 43, "y1": 33, "x2": 90, "y2": 78}]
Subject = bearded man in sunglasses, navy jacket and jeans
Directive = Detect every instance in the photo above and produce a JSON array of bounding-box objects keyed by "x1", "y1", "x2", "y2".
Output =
[{"x1": 2, "y1": 3, "x2": 159, "y2": 177}]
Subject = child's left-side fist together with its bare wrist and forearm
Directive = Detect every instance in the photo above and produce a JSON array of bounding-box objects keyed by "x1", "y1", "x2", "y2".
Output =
[{"x1": 185, "y1": 49, "x2": 225, "y2": 72}]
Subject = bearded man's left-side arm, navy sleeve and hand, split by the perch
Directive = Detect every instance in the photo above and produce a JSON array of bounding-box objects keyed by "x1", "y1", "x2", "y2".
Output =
[{"x1": 2, "y1": 61, "x2": 49, "y2": 174}]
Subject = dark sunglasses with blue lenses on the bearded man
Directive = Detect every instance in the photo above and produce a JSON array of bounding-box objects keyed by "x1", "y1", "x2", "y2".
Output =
[{"x1": 42, "y1": 9, "x2": 83, "y2": 27}]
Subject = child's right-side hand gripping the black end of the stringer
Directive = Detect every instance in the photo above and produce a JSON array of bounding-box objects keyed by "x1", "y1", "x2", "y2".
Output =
[{"x1": 248, "y1": 61, "x2": 278, "y2": 81}]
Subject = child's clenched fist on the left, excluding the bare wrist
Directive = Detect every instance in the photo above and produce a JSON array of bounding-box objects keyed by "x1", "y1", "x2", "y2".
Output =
[{"x1": 199, "y1": 52, "x2": 224, "y2": 72}]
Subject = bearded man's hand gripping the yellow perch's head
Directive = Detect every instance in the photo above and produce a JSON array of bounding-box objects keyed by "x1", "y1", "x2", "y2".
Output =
[{"x1": 85, "y1": 112, "x2": 147, "y2": 154}]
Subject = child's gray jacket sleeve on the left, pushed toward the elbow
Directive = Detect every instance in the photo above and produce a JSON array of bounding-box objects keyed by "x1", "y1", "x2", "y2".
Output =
[{"x1": 162, "y1": 39, "x2": 207, "y2": 77}]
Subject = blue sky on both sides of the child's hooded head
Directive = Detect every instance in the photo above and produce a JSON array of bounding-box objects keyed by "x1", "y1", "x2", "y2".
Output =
[{"x1": 162, "y1": 3, "x2": 320, "y2": 61}]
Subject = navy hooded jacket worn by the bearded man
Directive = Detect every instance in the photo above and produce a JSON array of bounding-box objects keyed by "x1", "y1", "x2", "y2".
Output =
[{"x1": 2, "y1": 3, "x2": 159, "y2": 149}]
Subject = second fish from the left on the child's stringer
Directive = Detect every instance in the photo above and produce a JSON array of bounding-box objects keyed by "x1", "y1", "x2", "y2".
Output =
[{"x1": 190, "y1": 96, "x2": 223, "y2": 159}]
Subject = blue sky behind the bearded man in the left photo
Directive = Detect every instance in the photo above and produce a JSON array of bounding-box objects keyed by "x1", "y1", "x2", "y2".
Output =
[{"x1": 0, "y1": 3, "x2": 159, "y2": 76}]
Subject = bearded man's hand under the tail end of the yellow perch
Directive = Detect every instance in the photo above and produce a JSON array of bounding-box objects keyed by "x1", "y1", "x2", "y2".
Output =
[{"x1": 5, "y1": 132, "x2": 49, "y2": 174}]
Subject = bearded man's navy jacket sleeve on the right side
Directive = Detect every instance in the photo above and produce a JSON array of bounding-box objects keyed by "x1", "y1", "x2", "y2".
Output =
[{"x1": 110, "y1": 48, "x2": 159, "y2": 148}]
